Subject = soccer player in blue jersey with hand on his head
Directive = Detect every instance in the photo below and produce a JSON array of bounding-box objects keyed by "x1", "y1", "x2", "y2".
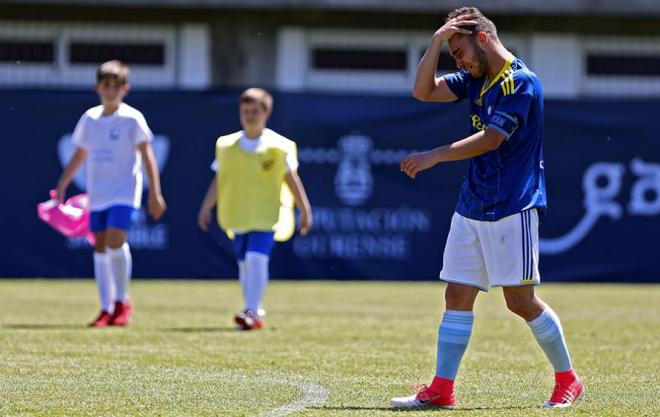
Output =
[{"x1": 391, "y1": 7, "x2": 584, "y2": 408}]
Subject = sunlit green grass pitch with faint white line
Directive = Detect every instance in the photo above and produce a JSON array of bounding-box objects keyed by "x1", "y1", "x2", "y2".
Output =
[{"x1": 0, "y1": 280, "x2": 660, "y2": 416}]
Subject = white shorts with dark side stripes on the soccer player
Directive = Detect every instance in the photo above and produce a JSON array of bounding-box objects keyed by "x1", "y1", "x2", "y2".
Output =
[{"x1": 440, "y1": 209, "x2": 541, "y2": 291}]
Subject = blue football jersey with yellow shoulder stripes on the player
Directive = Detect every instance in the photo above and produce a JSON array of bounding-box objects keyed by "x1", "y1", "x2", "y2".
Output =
[{"x1": 444, "y1": 58, "x2": 547, "y2": 221}]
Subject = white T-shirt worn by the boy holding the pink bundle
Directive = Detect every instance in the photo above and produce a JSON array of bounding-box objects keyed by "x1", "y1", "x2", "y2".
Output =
[{"x1": 72, "y1": 103, "x2": 153, "y2": 211}]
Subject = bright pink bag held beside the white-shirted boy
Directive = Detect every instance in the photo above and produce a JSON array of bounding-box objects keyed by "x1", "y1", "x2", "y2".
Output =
[{"x1": 37, "y1": 190, "x2": 94, "y2": 245}]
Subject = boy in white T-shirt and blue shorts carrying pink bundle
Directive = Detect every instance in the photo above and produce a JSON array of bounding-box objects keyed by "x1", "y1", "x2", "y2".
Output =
[{"x1": 57, "y1": 60, "x2": 166, "y2": 327}]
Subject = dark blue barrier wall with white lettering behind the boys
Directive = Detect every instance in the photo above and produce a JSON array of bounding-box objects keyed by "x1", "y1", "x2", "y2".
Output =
[{"x1": 0, "y1": 91, "x2": 660, "y2": 281}]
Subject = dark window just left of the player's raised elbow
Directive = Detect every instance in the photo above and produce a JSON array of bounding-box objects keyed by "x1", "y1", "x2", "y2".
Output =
[{"x1": 312, "y1": 48, "x2": 408, "y2": 71}]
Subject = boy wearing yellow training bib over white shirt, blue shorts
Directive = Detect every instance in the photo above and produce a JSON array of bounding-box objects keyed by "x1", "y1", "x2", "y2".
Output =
[{"x1": 197, "y1": 88, "x2": 312, "y2": 330}]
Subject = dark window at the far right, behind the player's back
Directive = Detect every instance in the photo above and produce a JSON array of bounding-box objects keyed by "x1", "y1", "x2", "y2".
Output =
[{"x1": 587, "y1": 54, "x2": 660, "y2": 77}]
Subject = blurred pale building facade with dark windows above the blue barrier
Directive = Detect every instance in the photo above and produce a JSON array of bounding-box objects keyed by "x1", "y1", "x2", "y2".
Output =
[{"x1": 0, "y1": 0, "x2": 660, "y2": 99}]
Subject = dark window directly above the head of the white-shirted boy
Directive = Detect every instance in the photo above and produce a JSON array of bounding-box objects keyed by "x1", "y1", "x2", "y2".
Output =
[{"x1": 69, "y1": 42, "x2": 165, "y2": 65}]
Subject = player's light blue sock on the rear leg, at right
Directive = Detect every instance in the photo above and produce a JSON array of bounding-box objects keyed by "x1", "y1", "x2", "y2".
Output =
[{"x1": 527, "y1": 307, "x2": 572, "y2": 372}]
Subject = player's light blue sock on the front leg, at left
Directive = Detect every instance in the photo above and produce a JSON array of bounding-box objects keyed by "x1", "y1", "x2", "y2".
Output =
[{"x1": 435, "y1": 310, "x2": 474, "y2": 381}]
